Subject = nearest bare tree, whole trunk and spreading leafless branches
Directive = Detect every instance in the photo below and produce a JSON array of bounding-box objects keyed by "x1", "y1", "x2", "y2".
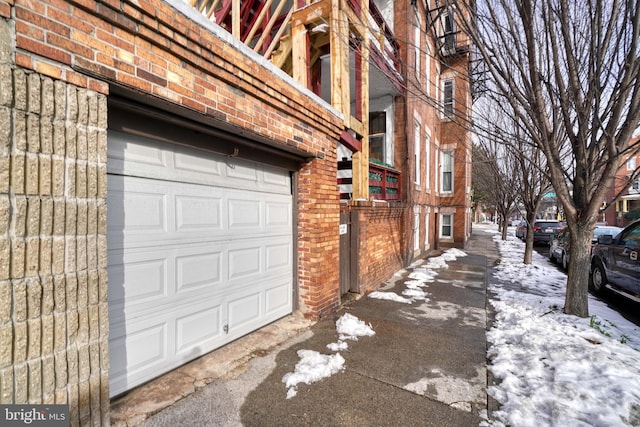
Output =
[{"x1": 449, "y1": 0, "x2": 640, "y2": 317}]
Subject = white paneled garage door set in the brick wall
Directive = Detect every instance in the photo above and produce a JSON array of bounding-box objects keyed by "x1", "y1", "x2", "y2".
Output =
[{"x1": 107, "y1": 131, "x2": 293, "y2": 396}]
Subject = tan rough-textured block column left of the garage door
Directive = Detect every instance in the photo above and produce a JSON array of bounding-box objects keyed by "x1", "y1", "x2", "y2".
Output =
[{"x1": 0, "y1": 21, "x2": 109, "y2": 425}]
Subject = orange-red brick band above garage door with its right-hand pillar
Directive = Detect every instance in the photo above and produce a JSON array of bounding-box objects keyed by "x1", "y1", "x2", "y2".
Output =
[{"x1": 10, "y1": 0, "x2": 341, "y2": 317}]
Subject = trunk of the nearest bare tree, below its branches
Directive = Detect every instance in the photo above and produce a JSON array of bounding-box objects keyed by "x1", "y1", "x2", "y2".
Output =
[{"x1": 564, "y1": 226, "x2": 593, "y2": 317}]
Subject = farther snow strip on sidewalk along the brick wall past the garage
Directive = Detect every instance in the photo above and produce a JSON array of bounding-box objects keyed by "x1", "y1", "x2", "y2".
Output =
[{"x1": 369, "y1": 248, "x2": 467, "y2": 304}]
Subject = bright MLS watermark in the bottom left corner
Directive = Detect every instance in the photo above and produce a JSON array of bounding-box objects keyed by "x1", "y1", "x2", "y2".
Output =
[{"x1": 0, "y1": 405, "x2": 69, "y2": 427}]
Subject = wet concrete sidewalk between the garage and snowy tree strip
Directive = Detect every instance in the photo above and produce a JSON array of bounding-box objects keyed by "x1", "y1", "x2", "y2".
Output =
[{"x1": 113, "y1": 225, "x2": 498, "y2": 426}]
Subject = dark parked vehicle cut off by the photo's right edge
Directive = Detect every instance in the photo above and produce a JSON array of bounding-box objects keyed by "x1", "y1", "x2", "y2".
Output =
[{"x1": 589, "y1": 220, "x2": 640, "y2": 302}]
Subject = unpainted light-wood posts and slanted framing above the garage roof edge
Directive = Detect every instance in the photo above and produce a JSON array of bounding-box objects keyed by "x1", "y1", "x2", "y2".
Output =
[{"x1": 189, "y1": 0, "x2": 383, "y2": 200}]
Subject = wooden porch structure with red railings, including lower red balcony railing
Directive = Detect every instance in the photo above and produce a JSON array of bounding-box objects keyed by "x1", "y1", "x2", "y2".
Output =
[{"x1": 185, "y1": 0, "x2": 403, "y2": 200}]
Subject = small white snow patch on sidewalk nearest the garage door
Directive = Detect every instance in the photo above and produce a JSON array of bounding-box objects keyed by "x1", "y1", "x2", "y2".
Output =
[{"x1": 282, "y1": 313, "x2": 375, "y2": 399}]
